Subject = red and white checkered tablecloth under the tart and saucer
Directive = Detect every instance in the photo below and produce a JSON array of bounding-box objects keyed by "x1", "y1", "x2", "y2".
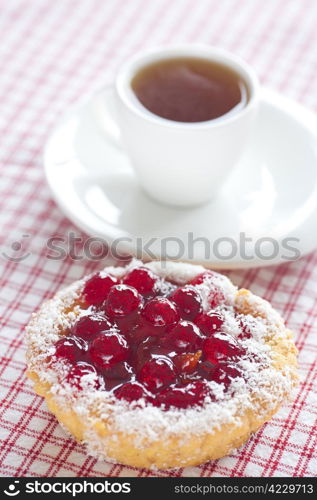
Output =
[{"x1": 0, "y1": 0, "x2": 317, "y2": 477}]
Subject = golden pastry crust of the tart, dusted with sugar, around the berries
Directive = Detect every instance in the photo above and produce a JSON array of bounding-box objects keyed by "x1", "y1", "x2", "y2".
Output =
[{"x1": 26, "y1": 262, "x2": 298, "y2": 469}]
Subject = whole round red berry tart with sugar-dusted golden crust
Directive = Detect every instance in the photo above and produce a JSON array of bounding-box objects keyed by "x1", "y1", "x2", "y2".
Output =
[{"x1": 26, "y1": 260, "x2": 297, "y2": 468}]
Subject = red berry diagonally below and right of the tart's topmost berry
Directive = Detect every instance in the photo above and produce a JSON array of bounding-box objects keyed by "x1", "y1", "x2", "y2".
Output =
[{"x1": 141, "y1": 297, "x2": 179, "y2": 335}]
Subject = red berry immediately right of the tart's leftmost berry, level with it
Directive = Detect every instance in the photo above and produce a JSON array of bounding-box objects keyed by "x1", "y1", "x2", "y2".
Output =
[{"x1": 89, "y1": 331, "x2": 129, "y2": 369}]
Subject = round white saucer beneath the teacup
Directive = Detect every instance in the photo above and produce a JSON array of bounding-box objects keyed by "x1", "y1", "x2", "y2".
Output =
[{"x1": 44, "y1": 90, "x2": 317, "y2": 269}]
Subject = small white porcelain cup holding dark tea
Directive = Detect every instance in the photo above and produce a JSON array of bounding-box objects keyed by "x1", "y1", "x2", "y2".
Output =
[{"x1": 100, "y1": 45, "x2": 259, "y2": 207}]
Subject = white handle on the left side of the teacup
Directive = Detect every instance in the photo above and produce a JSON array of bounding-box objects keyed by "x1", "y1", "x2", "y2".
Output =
[{"x1": 93, "y1": 87, "x2": 122, "y2": 149}]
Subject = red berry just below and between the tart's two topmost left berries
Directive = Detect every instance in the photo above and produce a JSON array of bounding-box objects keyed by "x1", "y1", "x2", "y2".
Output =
[{"x1": 106, "y1": 285, "x2": 142, "y2": 319}]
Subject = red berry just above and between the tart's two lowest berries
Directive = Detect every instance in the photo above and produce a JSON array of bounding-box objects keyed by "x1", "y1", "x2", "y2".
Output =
[{"x1": 139, "y1": 357, "x2": 176, "y2": 392}]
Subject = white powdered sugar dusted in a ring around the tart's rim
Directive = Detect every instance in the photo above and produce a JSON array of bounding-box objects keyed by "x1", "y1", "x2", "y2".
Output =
[{"x1": 27, "y1": 260, "x2": 295, "y2": 460}]
